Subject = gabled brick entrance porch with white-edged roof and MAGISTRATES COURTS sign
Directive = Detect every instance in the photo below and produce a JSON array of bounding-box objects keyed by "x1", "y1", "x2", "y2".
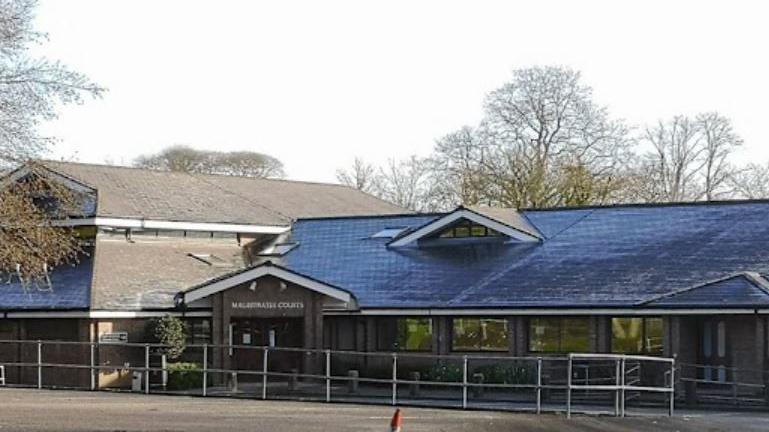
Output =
[{"x1": 178, "y1": 262, "x2": 357, "y2": 380}]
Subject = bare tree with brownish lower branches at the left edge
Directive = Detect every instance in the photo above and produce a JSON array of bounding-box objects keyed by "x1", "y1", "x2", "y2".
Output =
[{"x1": 0, "y1": 0, "x2": 104, "y2": 280}]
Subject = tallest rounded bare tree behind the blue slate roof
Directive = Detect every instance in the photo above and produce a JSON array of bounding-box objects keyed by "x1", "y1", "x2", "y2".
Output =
[{"x1": 460, "y1": 67, "x2": 632, "y2": 207}]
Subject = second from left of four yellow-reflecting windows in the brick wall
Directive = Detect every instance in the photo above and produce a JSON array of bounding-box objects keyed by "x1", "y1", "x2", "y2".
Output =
[{"x1": 451, "y1": 318, "x2": 508, "y2": 351}]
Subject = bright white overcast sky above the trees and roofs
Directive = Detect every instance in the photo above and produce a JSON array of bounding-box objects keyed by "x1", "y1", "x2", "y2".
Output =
[{"x1": 37, "y1": 0, "x2": 769, "y2": 181}]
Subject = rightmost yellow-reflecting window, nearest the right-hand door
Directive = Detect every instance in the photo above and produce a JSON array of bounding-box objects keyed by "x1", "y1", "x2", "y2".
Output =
[{"x1": 611, "y1": 317, "x2": 662, "y2": 355}]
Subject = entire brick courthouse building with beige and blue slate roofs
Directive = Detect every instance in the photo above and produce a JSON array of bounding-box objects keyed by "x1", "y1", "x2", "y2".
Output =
[{"x1": 0, "y1": 160, "x2": 769, "y2": 390}]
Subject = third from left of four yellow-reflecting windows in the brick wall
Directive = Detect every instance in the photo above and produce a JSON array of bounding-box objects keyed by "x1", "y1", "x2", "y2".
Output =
[{"x1": 529, "y1": 317, "x2": 590, "y2": 353}]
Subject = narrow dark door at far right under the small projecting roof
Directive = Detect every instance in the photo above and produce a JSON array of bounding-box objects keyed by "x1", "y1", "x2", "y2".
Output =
[{"x1": 699, "y1": 318, "x2": 729, "y2": 382}]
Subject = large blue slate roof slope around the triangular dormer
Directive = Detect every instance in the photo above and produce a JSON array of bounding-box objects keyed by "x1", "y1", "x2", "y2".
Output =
[{"x1": 278, "y1": 202, "x2": 769, "y2": 308}]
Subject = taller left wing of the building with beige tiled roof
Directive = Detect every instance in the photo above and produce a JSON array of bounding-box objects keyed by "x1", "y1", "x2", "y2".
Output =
[{"x1": 0, "y1": 161, "x2": 404, "y2": 381}]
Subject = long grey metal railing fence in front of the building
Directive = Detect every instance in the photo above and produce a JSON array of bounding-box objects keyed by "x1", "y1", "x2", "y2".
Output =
[{"x1": 0, "y1": 340, "x2": 675, "y2": 416}]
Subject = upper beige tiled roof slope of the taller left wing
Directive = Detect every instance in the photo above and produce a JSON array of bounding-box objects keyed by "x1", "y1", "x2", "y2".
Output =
[{"x1": 41, "y1": 161, "x2": 409, "y2": 226}]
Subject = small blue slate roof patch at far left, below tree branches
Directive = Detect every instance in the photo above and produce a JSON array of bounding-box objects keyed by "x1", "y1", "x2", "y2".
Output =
[{"x1": 0, "y1": 251, "x2": 93, "y2": 310}]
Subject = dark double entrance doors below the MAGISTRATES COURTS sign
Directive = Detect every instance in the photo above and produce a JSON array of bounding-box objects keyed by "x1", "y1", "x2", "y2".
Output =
[{"x1": 231, "y1": 318, "x2": 304, "y2": 378}]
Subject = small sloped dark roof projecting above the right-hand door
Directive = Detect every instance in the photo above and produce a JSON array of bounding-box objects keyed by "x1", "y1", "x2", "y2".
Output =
[{"x1": 644, "y1": 273, "x2": 769, "y2": 308}]
